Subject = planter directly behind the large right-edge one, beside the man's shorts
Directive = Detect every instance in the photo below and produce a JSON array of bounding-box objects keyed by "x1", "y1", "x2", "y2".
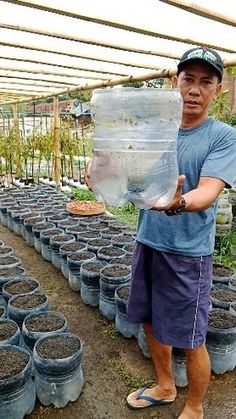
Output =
[{"x1": 211, "y1": 284, "x2": 236, "y2": 310}]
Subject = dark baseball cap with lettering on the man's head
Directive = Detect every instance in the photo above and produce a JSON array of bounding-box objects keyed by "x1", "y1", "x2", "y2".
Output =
[{"x1": 177, "y1": 47, "x2": 224, "y2": 81}]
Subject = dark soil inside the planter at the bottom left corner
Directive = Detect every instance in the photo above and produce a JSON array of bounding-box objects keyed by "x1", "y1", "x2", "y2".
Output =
[{"x1": 0, "y1": 348, "x2": 29, "y2": 380}]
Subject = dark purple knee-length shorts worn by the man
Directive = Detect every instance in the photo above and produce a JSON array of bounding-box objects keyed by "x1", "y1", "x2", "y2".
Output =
[{"x1": 127, "y1": 242, "x2": 212, "y2": 349}]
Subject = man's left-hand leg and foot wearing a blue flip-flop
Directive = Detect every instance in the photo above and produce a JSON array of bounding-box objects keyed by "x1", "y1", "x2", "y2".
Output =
[{"x1": 127, "y1": 324, "x2": 176, "y2": 406}]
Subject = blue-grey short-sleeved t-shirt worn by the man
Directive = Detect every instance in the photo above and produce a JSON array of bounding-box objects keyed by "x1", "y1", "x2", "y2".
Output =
[{"x1": 137, "y1": 118, "x2": 236, "y2": 256}]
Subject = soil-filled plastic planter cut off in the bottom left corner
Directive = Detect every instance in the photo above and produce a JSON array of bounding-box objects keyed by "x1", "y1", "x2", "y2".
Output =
[{"x1": 0, "y1": 345, "x2": 36, "y2": 419}]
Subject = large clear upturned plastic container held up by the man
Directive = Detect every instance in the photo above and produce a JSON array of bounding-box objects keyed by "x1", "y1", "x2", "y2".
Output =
[{"x1": 91, "y1": 88, "x2": 182, "y2": 208}]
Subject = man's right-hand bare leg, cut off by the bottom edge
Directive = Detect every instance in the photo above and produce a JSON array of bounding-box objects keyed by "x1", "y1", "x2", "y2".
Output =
[{"x1": 179, "y1": 345, "x2": 211, "y2": 419}]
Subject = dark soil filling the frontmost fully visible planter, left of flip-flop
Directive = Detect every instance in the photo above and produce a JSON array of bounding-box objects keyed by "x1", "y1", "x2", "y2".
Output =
[{"x1": 37, "y1": 336, "x2": 80, "y2": 359}]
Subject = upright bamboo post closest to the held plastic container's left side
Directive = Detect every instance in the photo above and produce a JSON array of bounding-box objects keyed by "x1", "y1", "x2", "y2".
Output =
[{"x1": 53, "y1": 97, "x2": 61, "y2": 188}]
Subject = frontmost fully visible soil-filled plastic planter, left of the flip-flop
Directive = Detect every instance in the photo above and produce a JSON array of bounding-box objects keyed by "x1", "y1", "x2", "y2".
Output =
[{"x1": 33, "y1": 333, "x2": 84, "y2": 408}]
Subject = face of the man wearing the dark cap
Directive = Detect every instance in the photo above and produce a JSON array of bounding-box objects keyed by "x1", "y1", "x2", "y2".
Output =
[{"x1": 177, "y1": 62, "x2": 221, "y2": 118}]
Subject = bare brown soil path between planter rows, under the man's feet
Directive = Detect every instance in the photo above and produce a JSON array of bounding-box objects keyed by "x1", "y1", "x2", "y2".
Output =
[{"x1": 0, "y1": 225, "x2": 236, "y2": 419}]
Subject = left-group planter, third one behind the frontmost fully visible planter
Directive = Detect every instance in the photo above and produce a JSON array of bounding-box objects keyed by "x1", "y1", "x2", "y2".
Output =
[{"x1": 2, "y1": 276, "x2": 41, "y2": 303}]
